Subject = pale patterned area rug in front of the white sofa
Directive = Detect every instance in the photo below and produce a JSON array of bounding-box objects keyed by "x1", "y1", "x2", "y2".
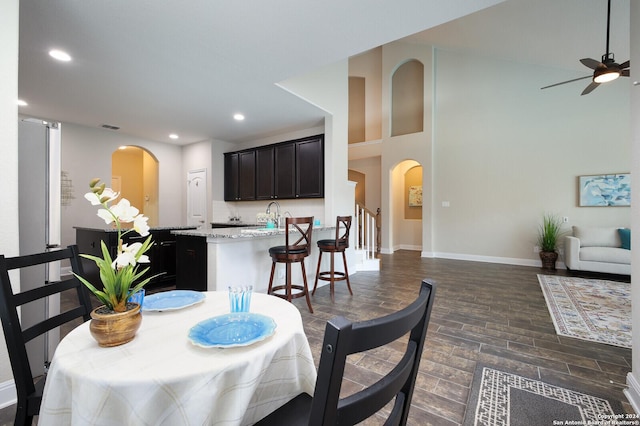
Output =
[{"x1": 538, "y1": 275, "x2": 631, "y2": 348}]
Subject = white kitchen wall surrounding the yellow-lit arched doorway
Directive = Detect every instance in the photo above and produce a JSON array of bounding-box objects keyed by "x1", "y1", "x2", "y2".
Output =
[{"x1": 62, "y1": 123, "x2": 186, "y2": 245}]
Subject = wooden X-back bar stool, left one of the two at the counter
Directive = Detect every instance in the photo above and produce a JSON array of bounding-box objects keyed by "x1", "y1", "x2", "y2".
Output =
[{"x1": 267, "y1": 216, "x2": 313, "y2": 313}]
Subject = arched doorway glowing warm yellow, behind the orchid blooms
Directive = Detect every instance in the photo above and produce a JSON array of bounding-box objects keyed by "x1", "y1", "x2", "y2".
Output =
[{"x1": 111, "y1": 146, "x2": 159, "y2": 226}]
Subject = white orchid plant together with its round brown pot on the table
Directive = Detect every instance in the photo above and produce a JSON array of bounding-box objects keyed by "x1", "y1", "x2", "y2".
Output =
[{"x1": 76, "y1": 179, "x2": 155, "y2": 346}]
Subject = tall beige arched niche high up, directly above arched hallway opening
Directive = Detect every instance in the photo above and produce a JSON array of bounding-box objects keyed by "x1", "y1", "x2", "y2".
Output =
[{"x1": 391, "y1": 59, "x2": 424, "y2": 136}]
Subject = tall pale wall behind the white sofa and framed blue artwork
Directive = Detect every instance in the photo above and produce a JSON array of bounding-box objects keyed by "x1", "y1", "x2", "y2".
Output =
[{"x1": 433, "y1": 50, "x2": 631, "y2": 259}]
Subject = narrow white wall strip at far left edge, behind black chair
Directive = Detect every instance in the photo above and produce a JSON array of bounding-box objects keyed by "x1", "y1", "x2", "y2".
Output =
[{"x1": 0, "y1": 0, "x2": 19, "y2": 402}]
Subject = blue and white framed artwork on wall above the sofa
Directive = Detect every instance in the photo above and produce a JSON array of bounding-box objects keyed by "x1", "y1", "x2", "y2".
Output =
[{"x1": 578, "y1": 173, "x2": 631, "y2": 207}]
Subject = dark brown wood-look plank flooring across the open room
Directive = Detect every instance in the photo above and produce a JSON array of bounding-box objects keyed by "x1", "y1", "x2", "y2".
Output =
[{"x1": 0, "y1": 251, "x2": 633, "y2": 426}]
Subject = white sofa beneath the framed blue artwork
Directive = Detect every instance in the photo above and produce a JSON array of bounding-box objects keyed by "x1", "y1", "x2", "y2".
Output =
[{"x1": 564, "y1": 226, "x2": 631, "y2": 275}]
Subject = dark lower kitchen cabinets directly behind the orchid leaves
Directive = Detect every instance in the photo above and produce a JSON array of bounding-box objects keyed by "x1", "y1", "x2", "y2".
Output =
[{"x1": 76, "y1": 227, "x2": 195, "y2": 287}]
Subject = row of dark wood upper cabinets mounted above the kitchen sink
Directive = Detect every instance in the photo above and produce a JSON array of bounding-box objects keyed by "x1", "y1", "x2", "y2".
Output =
[{"x1": 224, "y1": 135, "x2": 324, "y2": 201}]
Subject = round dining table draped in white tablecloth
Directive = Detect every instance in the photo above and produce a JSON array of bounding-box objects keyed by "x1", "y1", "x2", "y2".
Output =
[{"x1": 38, "y1": 290, "x2": 317, "y2": 426}]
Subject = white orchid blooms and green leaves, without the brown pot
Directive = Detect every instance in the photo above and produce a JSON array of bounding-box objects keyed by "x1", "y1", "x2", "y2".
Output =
[{"x1": 76, "y1": 178, "x2": 157, "y2": 312}]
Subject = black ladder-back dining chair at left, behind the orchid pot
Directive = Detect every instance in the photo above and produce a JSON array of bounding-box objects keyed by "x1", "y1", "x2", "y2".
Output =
[{"x1": 0, "y1": 245, "x2": 92, "y2": 425}]
